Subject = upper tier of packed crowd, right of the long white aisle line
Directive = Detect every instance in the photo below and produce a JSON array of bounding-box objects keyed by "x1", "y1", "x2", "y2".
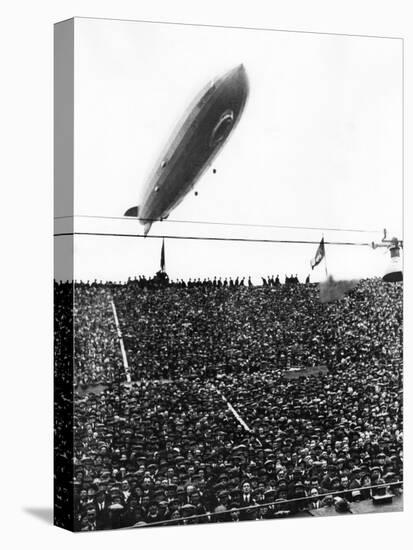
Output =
[{"x1": 115, "y1": 280, "x2": 402, "y2": 379}]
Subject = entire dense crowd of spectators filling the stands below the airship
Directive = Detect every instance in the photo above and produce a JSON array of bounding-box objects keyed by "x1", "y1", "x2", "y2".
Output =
[{"x1": 53, "y1": 278, "x2": 403, "y2": 530}]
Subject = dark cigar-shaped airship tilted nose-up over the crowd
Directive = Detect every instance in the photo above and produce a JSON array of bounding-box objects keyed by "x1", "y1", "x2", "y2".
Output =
[{"x1": 124, "y1": 64, "x2": 249, "y2": 236}]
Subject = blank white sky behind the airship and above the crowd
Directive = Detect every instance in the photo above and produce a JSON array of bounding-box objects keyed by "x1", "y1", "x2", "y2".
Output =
[{"x1": 57, "y1": 19, "x2": 402, "y2": 282}]
